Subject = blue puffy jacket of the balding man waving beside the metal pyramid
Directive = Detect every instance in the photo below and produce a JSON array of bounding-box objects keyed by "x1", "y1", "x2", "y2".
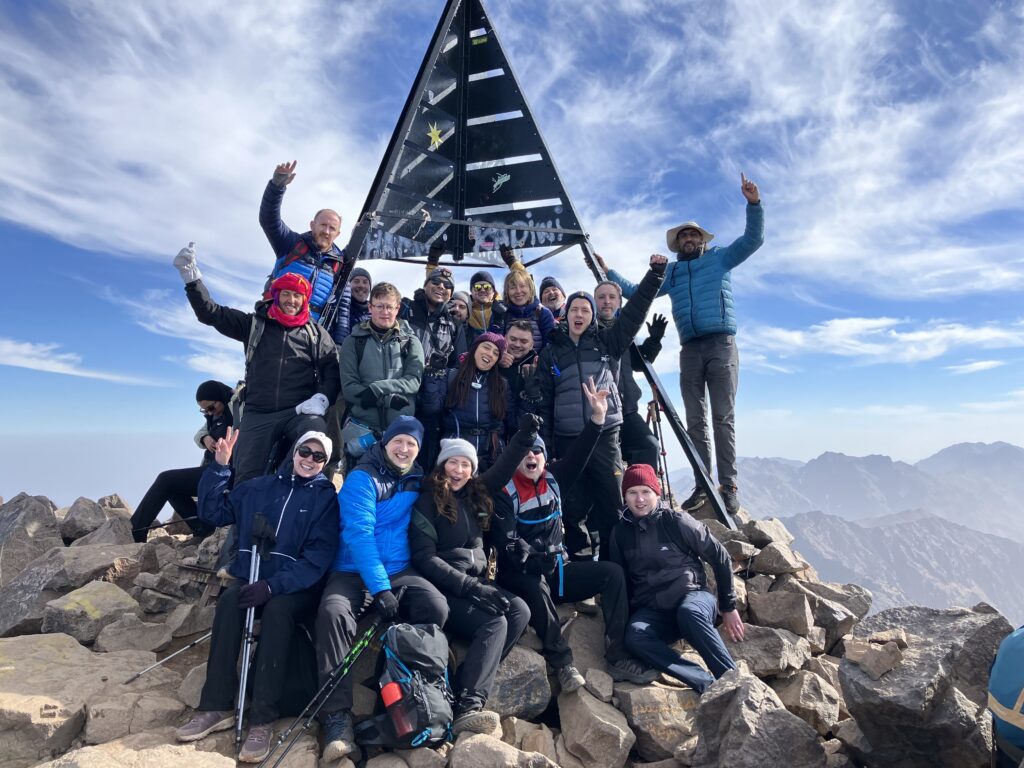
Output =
[{"x1": 259, "y1": 181, "x2": 345, "y2": 321}]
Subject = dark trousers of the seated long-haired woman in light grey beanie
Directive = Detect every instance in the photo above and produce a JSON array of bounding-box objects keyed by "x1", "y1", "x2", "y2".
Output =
[{"x1": 444, "y1": 588, "x2": 529, "y2": 712}]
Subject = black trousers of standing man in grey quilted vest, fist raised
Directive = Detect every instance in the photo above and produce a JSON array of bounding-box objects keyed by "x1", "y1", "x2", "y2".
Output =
[{"x1": 555, "y1": 427, "x2": 623, "y2": 560}]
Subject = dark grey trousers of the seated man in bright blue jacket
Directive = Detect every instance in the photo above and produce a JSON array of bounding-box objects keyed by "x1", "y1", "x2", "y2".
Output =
[{"x1": 316, "y1": 568, "x2": 449, "y2": 715}]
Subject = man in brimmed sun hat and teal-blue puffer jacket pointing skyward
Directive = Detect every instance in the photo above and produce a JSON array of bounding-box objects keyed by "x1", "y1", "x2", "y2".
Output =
[{"x1": 597, "y1": 174, "x2": 764, "y2": 514}]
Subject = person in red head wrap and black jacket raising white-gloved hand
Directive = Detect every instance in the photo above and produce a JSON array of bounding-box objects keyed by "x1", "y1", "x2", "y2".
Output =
[{"x1": 174, "y1": 243, "x2": 340, "y2": 483}]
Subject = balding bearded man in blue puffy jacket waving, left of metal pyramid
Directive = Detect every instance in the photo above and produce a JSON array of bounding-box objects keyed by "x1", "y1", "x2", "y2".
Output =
[{"x1": 259, "y1": 160, "x2": 344, "y2": 322}]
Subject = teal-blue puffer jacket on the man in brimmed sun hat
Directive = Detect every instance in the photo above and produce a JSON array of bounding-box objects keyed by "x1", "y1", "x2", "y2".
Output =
[{"x1": 608, "y1": 203, "x2": 765, "y2": 342}]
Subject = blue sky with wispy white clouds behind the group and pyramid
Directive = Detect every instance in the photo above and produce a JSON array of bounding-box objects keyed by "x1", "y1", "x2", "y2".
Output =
[{"x1": 0, "y1": 0, "x2": 1024, "y2": 512}]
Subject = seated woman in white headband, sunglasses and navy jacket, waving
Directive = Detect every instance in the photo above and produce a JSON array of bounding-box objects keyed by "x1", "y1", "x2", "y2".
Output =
[{"x1": 175, "y1": 428, "x2": 338, "y2": 763}]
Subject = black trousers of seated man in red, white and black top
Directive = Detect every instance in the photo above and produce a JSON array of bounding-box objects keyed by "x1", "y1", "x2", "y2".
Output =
[{"x1": 498, "y1": 561, "x2": 629, "y2": 669}]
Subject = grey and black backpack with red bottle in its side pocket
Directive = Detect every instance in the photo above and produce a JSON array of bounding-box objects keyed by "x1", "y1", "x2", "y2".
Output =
[{"x1": 357, "y1": 624, "x2": 455, "y2": 750}]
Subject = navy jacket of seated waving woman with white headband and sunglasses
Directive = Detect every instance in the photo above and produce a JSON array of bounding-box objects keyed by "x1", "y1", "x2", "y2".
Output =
[{"x1": 199, "y1": 462, "x2": 338, "y2": 595}]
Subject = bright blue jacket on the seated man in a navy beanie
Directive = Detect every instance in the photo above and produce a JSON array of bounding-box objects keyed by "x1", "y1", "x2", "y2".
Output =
[{"x1": 334, "y1": 442, "x2": 423, "y2": 595}]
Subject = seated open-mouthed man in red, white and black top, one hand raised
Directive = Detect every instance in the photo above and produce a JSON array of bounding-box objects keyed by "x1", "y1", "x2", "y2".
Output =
[{"x1": 490, "y1": 379, "x2": 654, "y2": 692}]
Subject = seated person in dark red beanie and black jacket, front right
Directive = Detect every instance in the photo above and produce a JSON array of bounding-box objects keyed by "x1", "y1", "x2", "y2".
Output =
[{"x1": 610, "y1": 464, "x2": 743, "y2": 693}]
